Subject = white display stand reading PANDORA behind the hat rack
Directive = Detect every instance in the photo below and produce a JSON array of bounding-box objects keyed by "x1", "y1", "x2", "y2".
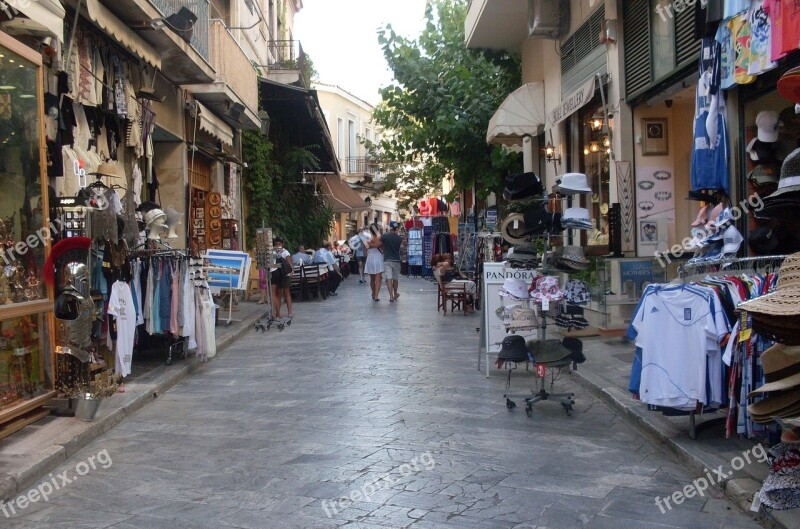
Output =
[{"x1": 478, "y1": 261, "x2": 539, "y2": 378}]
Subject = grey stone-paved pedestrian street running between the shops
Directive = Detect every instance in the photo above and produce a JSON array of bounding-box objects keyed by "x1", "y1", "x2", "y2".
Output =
[{"x1": 0, "y1": 276, "x2": 758, "y2": 529}]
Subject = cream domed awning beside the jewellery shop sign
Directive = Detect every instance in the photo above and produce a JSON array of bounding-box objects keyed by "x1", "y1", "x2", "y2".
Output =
[{"x1": 486, "y1": 83, "x2": 545, "y2": 145}]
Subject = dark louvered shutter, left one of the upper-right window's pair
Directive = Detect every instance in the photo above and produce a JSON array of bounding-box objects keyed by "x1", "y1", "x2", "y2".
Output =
[{"x1": 622, "y1": 1, "x2": 653, "y2": 98}]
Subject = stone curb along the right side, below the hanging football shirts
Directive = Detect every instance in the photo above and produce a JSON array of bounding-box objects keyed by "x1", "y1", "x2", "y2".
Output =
[{"x1": 570, "y1": 371, "x2": 795, "y2": 529}]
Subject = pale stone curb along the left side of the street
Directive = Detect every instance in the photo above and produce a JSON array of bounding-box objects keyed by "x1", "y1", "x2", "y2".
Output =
[{"x1": 0, "y1": 306, "x2": 263, "y2": 501}]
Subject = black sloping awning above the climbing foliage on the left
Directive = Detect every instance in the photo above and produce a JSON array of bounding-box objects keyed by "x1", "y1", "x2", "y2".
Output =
[{"x1": 259, "y1": 79, "x2": 340, "y2": 174}]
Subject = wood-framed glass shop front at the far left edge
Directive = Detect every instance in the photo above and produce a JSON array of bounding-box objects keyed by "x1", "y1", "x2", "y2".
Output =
[{"x1": 0, "y1": 33, "x2": 55, "y2": 437}]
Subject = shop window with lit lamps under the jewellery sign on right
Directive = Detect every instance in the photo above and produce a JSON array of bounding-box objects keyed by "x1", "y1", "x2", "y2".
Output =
[{"x1": 578, "y1": 103, "x2": 611, "y2": 251}]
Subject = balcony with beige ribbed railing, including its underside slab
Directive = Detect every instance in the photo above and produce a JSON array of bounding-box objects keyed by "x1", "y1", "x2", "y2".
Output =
[{"x1": 184, "y1": 20, "x2": 261, "y2": 130}]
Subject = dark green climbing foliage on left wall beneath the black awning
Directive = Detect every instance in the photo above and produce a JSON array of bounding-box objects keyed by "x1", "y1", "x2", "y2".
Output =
[{"x1": 242, "y1": 131, "x2": 333, "y2": 248}]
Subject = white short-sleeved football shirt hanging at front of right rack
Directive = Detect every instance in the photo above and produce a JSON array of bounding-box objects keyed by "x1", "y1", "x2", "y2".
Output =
[{"x1": 631, "y1": 290, "x2": 725, "y2": 409}]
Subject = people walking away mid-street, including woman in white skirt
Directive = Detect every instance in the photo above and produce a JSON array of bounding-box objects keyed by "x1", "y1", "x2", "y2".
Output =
[{"x1": 348, "y1": 221, "x2": 402, "y2": 303}]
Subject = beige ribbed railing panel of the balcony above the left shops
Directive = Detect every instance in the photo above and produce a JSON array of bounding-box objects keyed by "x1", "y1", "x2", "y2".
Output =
[{"x1": 210, "y1": 20, "x2": 258, "y2": 110}]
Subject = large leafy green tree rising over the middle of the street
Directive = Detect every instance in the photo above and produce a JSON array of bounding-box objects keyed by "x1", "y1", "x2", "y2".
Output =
[{"x1": 368, "y1": 0, "x2": 521, "y2": 204}]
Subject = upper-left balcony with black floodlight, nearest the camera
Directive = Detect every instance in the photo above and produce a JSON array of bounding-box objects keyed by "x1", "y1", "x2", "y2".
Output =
[{"x1": 101, "y1": 0, "x2": 214, "y2": 85}]
